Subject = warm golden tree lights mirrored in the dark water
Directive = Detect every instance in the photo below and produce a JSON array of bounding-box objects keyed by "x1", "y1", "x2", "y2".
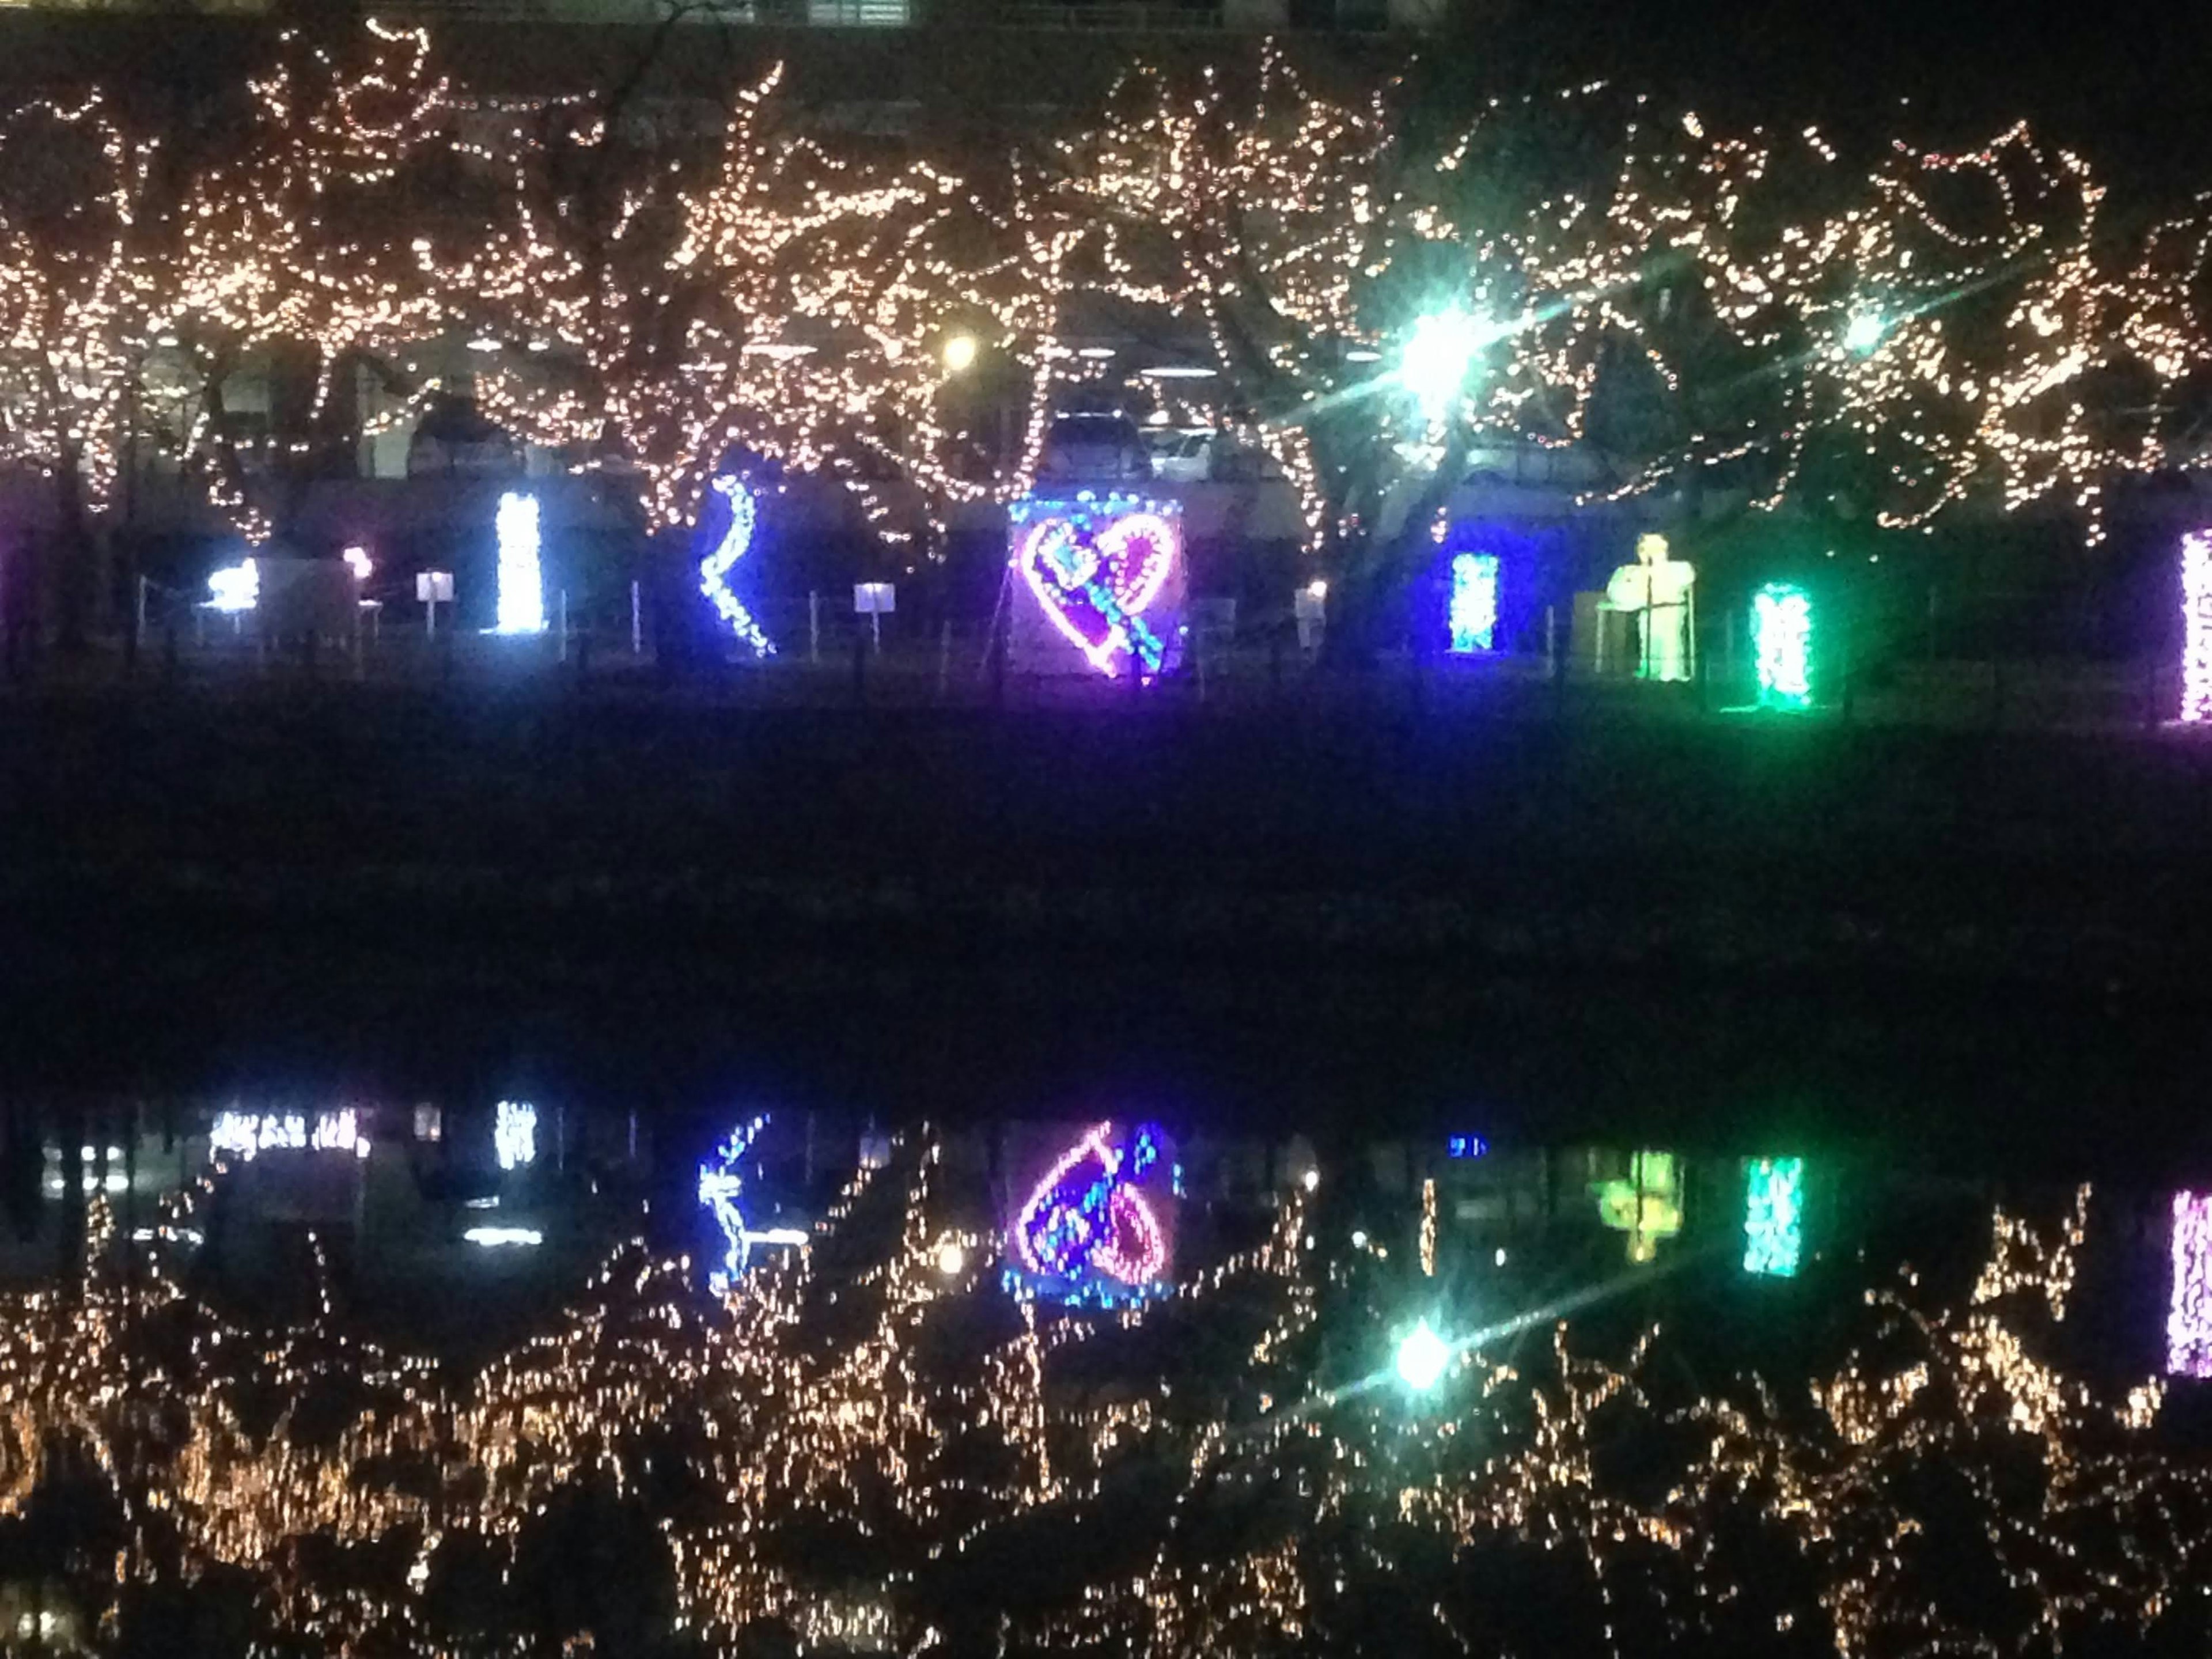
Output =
[{"x1": 0, "y1": 1130, "x2": 2212, "y2": 1659}]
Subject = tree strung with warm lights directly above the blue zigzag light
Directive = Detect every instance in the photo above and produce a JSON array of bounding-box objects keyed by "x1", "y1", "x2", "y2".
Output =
[{"x1": 440, "y1": 44, "x2": 1058, "y2": 570}]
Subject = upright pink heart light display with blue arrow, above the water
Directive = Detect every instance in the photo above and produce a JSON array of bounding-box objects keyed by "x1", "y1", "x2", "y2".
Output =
[{"x1": 1009, "y1": 489, "x2": 1183, "y2": 677}]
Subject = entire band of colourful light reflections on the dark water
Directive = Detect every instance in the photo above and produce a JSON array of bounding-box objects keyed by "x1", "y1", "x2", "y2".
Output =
[{"x1": 0, "y1": 1099, "x2": 2212, "y2": 1657}]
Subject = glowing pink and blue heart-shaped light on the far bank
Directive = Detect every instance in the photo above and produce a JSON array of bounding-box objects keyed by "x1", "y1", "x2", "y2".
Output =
[{"x1": 1013, "y1": 511, "x2": 1183, "y2": 675}]
